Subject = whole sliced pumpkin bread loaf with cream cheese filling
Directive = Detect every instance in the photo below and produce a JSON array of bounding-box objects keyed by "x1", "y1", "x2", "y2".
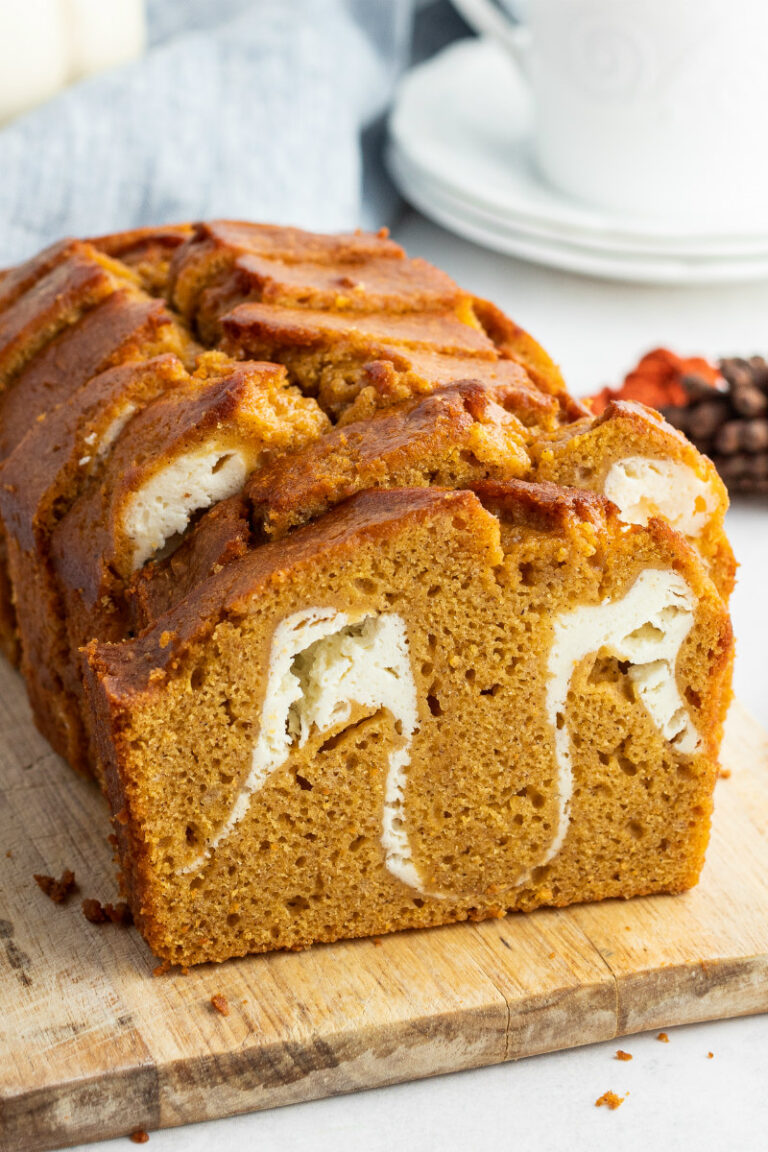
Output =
[{"x1": 0, "y1": 221, "x2": 733, "y2": 963}]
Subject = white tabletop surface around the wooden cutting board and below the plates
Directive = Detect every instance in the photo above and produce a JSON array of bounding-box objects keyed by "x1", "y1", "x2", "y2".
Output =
[{"x1": 63, "y1": 209, "x2": 768, "y2": 1152}]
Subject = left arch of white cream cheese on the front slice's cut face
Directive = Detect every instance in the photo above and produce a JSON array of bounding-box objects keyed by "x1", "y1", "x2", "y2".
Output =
[{"x1": 181, "y1": 608, "x2": 423, "y2": 892}]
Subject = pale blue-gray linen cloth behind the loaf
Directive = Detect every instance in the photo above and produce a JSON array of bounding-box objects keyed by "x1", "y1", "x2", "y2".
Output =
[{"x1": 0, "y1": 0, "x2": 410, "y2": 267}]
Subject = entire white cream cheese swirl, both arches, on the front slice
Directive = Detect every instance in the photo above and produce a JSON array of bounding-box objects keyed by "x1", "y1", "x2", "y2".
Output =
[{"x1": 180, "y1": 569, "x2": 701, "y2": 899}]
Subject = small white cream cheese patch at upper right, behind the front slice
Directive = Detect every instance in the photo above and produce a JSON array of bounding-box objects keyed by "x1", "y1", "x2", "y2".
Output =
[{"x1": 602, "y1": 456, "x2": 717, "y2": 539}]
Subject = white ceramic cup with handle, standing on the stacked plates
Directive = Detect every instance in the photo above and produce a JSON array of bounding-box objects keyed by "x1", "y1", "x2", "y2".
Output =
[{"x1": 454, "y1": 0, "x2": 768, "y2": 233}]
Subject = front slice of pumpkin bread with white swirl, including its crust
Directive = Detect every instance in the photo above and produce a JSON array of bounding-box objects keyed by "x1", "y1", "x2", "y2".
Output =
[{"x1": 88, "y1": 482, "x2": 730, "y2": 963}]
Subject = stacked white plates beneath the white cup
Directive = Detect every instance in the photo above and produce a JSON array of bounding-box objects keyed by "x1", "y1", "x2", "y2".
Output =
[{"x1": 388, "y1": 39, "x2": 768, "y2": 283}]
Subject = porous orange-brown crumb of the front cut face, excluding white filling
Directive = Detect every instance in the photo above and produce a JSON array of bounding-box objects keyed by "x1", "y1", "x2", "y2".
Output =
[{"x1": 103, "y1": 495, "x2": 727, "y2": 963}]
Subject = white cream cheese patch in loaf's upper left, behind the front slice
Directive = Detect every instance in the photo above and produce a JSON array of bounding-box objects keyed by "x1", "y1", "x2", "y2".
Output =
[{"x1": 122, "y1": 448, "x2": 248, "y2": 571}]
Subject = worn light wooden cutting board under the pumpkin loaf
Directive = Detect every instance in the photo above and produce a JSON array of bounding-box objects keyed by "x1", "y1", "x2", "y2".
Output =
[{"x1": 0, "y1": 664, "x2": 768, "y2": 1152}]
